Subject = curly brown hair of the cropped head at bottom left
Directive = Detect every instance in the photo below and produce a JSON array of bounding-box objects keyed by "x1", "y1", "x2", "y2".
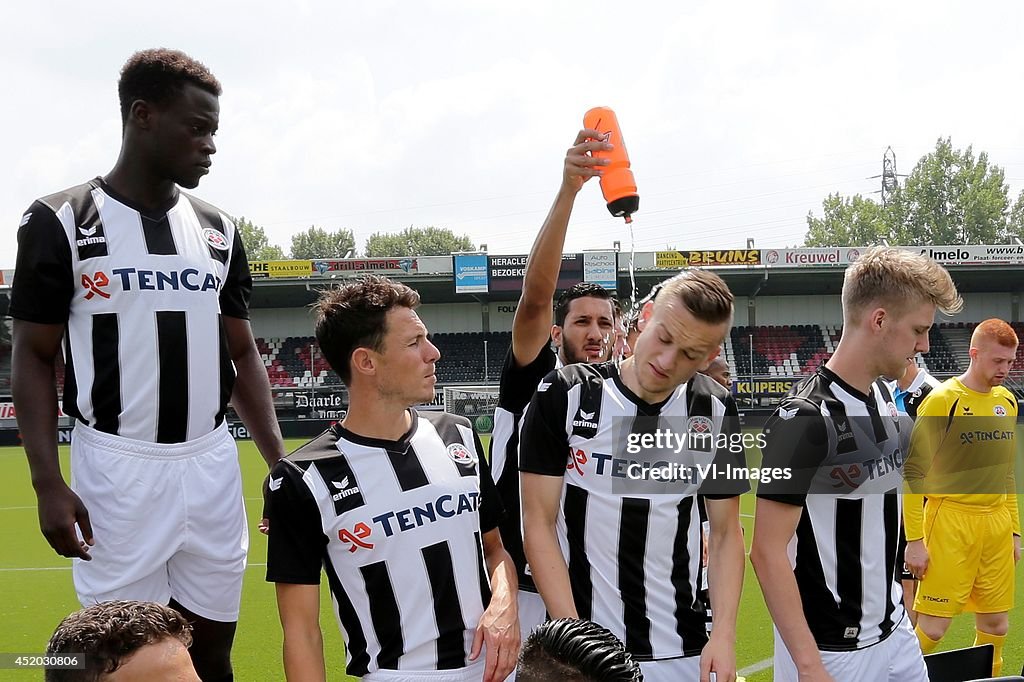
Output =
[{"x1": 43, "y1": 600, "x2": 191, "y2": 682}]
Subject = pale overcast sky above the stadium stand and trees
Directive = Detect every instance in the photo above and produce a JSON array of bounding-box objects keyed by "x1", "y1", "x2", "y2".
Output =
[{"x1": 6, "y1": 0, "x2": 1024, "y2": 268}]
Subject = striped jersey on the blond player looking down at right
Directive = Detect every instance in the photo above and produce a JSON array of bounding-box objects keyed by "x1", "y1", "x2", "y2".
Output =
[{"x1": 758, "y1": 367, "x2": 904, "y2": 651}]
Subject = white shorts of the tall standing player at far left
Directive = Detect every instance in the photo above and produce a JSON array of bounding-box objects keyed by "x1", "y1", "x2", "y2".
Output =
[{"x1": 71, "y1": 423, "x2": 249, "y2": 623}]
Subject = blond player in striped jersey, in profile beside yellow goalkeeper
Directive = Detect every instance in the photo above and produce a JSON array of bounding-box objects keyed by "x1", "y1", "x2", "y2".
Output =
[{"x1": 751, "y1": 248, "x2": 963, "y2": 682}]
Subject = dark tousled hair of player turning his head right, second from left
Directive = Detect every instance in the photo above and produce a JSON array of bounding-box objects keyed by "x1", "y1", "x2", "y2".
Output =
[{"x1": 313, "y1": 274, "x2": 420, "y2": 385}]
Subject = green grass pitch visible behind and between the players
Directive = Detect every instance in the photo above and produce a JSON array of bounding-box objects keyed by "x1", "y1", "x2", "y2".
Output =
[{"x1": 0, "y1": 432, "x2": 1024, "y2": 682}]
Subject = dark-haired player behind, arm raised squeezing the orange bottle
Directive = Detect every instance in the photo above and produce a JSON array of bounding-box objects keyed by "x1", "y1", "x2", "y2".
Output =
[{"x1": 490, "y1": 129, "x2": 615, "y2": 638}]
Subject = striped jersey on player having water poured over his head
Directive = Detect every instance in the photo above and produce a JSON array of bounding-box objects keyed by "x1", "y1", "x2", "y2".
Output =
[{"x1": 519, "y1": 363, "x2": 750, "y2": 660}]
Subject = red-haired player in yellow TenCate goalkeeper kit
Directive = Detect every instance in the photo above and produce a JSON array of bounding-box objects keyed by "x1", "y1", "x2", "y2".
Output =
[{"x1": 903, "y1": 319, "x2": 1021, "y2": 677}]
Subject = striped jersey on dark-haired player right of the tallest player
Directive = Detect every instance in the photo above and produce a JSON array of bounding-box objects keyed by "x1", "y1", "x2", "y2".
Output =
[{"x1": 266, "y1": 410, "x2": 502, "y2": 677}]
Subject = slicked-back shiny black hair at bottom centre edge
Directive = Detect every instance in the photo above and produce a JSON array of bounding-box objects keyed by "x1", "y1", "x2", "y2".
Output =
[{"x1": 516, "y1": 619, "x2": 643, "y2": 682}]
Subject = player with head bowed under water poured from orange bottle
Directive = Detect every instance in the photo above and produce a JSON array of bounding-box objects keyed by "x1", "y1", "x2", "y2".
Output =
[{"x1": 519, "y1": 269, "x2": 750, "y2": 682}]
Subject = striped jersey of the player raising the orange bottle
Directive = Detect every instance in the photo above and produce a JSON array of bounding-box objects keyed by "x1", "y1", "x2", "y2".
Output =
[{"x1": 490, "y1": 345, "x2": 558, "y2": 592}]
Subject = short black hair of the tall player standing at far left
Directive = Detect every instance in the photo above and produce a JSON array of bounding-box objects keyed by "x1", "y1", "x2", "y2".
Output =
[{"x1": 118, "y1": 47, "x2": 221, "y2": 125}]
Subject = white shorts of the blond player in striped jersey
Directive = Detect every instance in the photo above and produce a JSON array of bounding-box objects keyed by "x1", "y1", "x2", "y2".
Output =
[{"x1": 775, "y1": 617, "x2": 928, "y2": 682}]
